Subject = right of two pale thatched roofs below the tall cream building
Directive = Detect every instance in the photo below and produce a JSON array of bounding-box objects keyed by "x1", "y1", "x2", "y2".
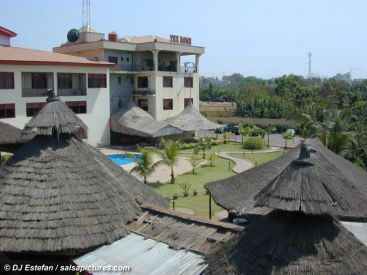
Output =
[{"x1": 166, "y1": 104, "x2": 223, "y2": 131}]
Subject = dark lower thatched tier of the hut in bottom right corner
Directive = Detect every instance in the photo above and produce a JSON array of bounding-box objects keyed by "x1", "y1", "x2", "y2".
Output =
[{"x1": 204, "y1": 210, "x2": 367, "y2": 275}]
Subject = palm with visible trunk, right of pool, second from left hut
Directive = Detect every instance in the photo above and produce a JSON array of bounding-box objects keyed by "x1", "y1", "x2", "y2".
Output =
[{"x1": 155, "y1": 138, "x2": 180, "y2": 183}]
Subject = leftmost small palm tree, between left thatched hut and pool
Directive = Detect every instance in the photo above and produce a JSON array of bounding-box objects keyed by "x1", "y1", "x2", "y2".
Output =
[{"x1": 124, "y1": 147, "x2": 159, "y2": 184}]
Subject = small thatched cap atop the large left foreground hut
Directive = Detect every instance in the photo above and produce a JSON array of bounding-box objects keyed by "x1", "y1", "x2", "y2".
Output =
[{"x1": 23, "y1": 97, "x2": 88, "y2": 138}]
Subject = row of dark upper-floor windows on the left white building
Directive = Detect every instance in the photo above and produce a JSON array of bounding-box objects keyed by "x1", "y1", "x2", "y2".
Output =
[{"x1": 0, "y1": 72, "x2": 107, "y2": 89}]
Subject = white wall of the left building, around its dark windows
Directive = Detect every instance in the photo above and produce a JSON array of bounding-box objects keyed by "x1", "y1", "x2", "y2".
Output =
[{"x1": 0, "y1": 65, "x2": 110, "y2": 146}]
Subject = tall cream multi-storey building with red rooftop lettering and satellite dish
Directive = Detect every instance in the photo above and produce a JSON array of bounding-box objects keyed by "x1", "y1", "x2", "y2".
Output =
[{"x1": 53, "y1": 26, "x2": 204, "y2": 121}]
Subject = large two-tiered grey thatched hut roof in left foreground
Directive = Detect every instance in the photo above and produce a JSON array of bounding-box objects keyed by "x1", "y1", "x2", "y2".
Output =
[{"x1": 0, "y1": 95, "x2": 166, "y2": 255}]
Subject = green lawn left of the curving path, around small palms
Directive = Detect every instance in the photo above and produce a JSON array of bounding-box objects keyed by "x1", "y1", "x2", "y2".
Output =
[{"x1": 150, "y1": 155, "x2": 235, "y2": 217}]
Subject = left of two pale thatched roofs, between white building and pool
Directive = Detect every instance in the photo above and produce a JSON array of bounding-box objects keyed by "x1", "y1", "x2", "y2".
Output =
[{"x1": 110, "y1": 103, "x2": 182, "y2": 137}]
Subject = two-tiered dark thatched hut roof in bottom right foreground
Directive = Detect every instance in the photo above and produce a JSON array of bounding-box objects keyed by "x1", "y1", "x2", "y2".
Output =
[{"x1": 205, "y1": 145, "x2": 367, "y2": 274}]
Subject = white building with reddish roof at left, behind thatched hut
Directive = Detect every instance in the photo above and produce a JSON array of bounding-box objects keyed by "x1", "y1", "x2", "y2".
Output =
[{"x1": 0, "y1": 27, "x2": 113, "y2": 146}]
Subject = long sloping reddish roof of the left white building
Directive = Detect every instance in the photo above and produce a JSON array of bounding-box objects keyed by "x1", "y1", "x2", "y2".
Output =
[{"x1": 0, "y1": 47, "x2": 114, "y2": 67}]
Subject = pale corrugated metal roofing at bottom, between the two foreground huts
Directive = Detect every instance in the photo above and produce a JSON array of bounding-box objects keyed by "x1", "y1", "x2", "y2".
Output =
[{"x1": 74, "y1": 233, "x2": 207, "y2": 275}]
